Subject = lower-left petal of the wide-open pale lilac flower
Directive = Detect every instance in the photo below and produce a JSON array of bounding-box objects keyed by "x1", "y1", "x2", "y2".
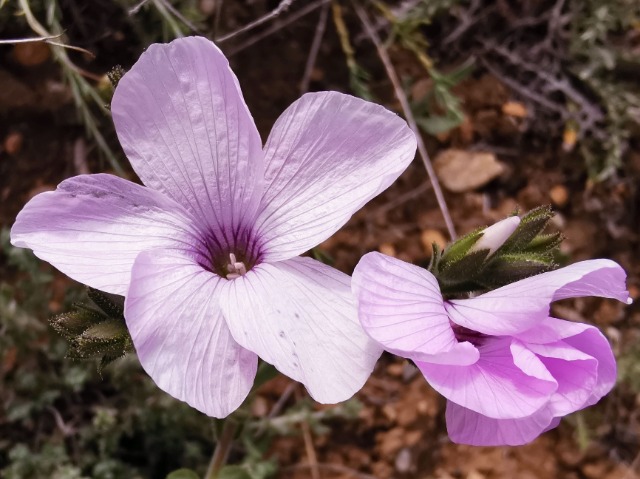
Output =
[{"x1": 125, "y1": 250, "x2": 258, "y2": 418}]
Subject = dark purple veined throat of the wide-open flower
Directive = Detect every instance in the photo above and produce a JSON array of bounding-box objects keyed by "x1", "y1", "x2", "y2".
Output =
[{"x1": 199, "y1": 228, "x2": 263, "y2": 279}]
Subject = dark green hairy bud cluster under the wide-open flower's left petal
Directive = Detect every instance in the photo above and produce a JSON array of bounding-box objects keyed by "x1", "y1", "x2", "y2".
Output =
[{"x1": 50, "y1": 288, "x2": 133, "y2": 372}]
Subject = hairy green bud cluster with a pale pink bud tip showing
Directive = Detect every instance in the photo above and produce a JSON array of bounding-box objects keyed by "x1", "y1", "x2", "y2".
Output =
[{"x1": 429, "y1": 206, "x2": 563, "y2": 298}]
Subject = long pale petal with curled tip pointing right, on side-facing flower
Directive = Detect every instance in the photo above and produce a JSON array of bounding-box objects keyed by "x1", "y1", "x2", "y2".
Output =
[{"x1": 446, "y1": 259, "x2": 629, "y2": 336}]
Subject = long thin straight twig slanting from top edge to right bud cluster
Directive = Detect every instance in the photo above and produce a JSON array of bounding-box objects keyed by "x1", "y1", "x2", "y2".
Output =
[{"x1": 353, "y1": 1, "x2": 457, "y2": 240}]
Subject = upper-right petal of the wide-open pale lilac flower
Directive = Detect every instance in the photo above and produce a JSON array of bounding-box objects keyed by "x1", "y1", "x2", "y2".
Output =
[{"x1": 256, "y1": 92, "x2": 416, "y2": 261}]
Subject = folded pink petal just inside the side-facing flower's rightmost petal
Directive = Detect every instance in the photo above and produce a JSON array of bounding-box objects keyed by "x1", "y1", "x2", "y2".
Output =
[{"x1": 526, "y1": 341, "x2": 598, "y2": 416}]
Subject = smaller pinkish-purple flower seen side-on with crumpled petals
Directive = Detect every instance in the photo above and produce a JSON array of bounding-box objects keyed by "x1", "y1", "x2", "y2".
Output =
[{"x1": 352, "y1": 253, "x2": 629, "y2": 446}]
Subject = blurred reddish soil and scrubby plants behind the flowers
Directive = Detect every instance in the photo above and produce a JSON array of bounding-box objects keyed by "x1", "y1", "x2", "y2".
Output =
[{"x1": 0, "y1": 0, "x2": 640, "y2": 479}]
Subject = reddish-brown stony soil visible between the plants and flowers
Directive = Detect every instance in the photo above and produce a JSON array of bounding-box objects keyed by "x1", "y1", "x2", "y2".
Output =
[{"x1": 0, "y1": 0, "x2": 640, "y2": 479}]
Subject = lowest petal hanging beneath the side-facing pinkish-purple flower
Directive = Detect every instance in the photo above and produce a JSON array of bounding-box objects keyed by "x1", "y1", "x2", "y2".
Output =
[{"x1": 446, "y1": 401, "x2": 557, "y2": 446}]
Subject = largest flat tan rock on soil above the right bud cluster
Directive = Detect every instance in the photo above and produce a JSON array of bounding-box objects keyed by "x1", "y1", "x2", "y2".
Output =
[{"x1": 433, "y1": 149, "x2": 505, "y2": 193}]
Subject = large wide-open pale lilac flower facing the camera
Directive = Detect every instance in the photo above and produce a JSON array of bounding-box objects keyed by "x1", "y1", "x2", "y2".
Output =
[{"x1": 11, "y1": 37, "x2": 416, "y2": 417}]
